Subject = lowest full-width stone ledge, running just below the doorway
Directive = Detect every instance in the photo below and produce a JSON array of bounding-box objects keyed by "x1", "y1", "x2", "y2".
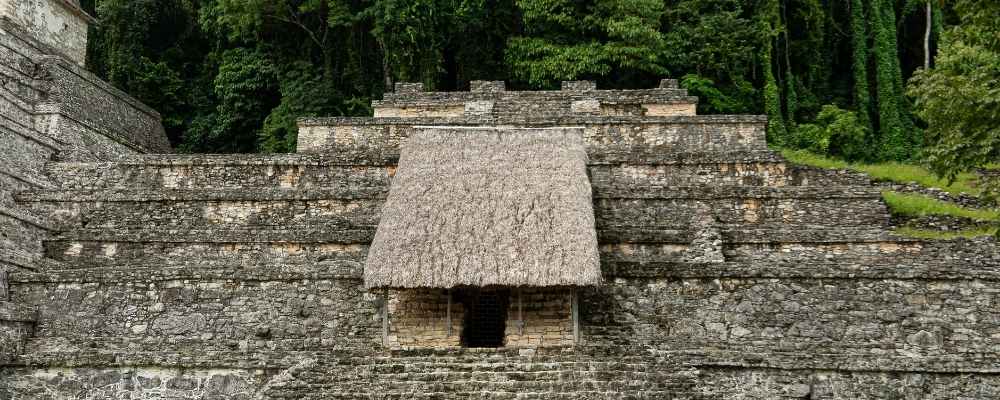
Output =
[{"x1": 11, "y1": 344, "x2": 1000, "y2": 375}]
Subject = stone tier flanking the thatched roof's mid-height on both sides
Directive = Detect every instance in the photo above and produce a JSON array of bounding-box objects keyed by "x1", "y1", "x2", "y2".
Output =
[{"x1": 15, "y1": 187, "x2": 889, "y2": 230}]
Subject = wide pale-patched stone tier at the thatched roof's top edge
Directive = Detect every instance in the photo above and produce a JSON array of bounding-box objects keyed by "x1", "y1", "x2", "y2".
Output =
[{"x1": 298, "y1": 114, "x2": 767, "y2": 155}]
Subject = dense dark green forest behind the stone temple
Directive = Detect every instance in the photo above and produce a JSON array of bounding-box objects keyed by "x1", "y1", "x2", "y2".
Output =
[{"x1": 83, "y1": 0, "x2": 1000, "y2": 178}]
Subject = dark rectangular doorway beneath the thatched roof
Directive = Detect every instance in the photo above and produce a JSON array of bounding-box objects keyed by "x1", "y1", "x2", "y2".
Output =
[{"x1": 461, "y1": 289, "x2": 510, "y2": 347}]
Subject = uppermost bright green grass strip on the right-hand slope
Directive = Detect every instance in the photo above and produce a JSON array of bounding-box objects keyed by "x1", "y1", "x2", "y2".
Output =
[{"x1": 781, "y1": 149, "x2": 984, "y2": 195}]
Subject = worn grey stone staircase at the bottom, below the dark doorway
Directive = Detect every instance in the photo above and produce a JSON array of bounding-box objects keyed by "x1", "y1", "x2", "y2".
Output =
[{"x1": 262, "y1": 348, "x2": 697, "y2": 399}]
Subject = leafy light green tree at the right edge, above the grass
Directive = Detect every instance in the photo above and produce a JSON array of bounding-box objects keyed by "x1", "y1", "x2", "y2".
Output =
[{"x1": 909, "y1": 0, "x2": 1000, "y2": 203}]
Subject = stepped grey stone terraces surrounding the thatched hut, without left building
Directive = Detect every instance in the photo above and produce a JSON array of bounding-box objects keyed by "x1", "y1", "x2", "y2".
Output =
[{"x1": 0, "y1": 80, "x2": 1000, "y2": 399}]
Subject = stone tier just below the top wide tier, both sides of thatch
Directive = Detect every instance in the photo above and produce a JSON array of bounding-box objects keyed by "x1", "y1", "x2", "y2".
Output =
[{"x1": 47, "y1": 151, "x2": 868, "y2": 189}]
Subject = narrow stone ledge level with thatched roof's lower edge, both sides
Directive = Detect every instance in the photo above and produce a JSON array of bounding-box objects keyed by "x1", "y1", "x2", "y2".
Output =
[{"x1": 10, "y1": 259, "x2": 1000, "y2": 286}]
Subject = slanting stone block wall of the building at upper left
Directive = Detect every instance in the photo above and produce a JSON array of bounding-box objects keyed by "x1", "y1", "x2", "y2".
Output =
[{"x1": 0, "y1": 10, "x2": 170, "y2": 270}]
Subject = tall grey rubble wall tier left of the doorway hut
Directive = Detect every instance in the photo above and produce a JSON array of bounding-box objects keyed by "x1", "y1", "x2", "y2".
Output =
[{"x1": 12, "y1": 274, "x2": 374, "y2": 356}]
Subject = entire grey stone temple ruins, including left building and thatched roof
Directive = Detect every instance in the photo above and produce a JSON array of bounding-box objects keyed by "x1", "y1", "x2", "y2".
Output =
[{"x1": 0, "y1": 0, "x2": 1000, "y2": 400}]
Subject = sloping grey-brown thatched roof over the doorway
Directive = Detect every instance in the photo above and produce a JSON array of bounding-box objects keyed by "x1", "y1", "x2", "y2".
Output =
[{"x1": 365, "y1": 127, "x2": 601, "y2": 289}]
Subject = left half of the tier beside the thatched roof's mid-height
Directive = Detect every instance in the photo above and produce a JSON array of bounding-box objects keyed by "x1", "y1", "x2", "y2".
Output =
[{"x1": 18, "y1": 189, "x2": 384, "y2": 230}]
